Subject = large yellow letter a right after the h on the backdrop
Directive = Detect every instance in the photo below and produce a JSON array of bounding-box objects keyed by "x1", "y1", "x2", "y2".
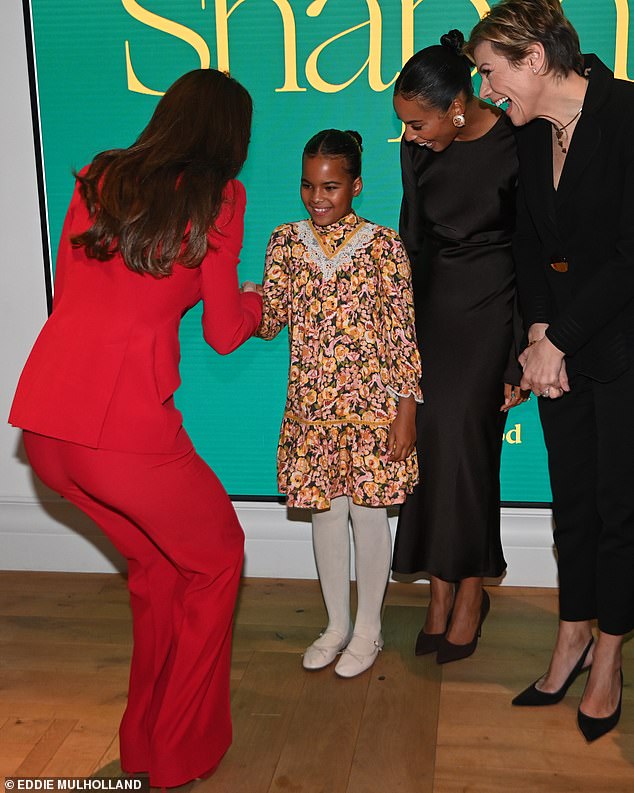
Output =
[{"x1": 306, "y1": 0, "x2": 398, "y2": 94}]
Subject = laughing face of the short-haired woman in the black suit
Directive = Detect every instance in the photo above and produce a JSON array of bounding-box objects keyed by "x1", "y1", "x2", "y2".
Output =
[{"x1": 473, "y1": 41, "x2": 543, "y2": 127}]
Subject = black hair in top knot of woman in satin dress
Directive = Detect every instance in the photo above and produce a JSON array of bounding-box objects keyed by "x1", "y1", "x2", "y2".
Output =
[{"x1": 394, "y1": 30, "x2": 473, "y2": 112}]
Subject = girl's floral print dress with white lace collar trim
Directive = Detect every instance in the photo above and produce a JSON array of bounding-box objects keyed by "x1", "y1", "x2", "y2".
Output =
[{"x1": 256, "y1": 212, "x2": 422, "y2": 510}]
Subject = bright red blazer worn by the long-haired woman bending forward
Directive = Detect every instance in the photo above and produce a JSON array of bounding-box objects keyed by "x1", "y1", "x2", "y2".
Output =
[{"x1": 9, "y1": 181, "x2": 262, "y2": 452}]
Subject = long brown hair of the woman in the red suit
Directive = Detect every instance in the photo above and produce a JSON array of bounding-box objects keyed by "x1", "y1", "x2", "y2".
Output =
[{"x1": 71, "y1": 69, "x2": 252, "y2": 278}]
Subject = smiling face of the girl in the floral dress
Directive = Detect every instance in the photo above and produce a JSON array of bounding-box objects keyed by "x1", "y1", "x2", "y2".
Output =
[{"x1": 300, "y1": 154, "x2": 363, "y2": 226}]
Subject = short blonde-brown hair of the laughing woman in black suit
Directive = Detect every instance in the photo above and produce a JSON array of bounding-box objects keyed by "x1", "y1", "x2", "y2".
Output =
[{"x1": 464, "y1": 0, "x2": 583, "y2": 77}]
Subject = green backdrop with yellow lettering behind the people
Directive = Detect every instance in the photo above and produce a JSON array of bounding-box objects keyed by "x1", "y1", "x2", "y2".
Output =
[{"x1": 25, "y1": 0, "x2": 634, "y2": 502}]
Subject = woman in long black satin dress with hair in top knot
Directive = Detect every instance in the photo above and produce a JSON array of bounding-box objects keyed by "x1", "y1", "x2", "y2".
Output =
[{"x1": 393, "y1": 31, "x2": 523, "y2": 663}]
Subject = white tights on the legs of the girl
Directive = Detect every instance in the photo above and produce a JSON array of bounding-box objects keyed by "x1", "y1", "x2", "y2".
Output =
[{"x1": 313, "y1": 496, "x2": 392, "y2": 641}]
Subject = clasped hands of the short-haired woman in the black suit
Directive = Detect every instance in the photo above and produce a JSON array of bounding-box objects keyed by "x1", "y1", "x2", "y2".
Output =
[{"x1": 518, "y1": 323, "x2": 570, "y2": 399}]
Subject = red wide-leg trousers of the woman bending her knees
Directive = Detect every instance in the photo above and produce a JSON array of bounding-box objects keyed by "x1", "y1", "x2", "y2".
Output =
[{"x1": 24, "y1": 432, "x2": 244, "y2": 787}]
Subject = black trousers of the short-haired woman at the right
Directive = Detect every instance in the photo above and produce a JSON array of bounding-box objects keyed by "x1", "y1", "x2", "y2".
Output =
[{"x1": 539, "y1": 367, "x2": 634, "y2": 635}]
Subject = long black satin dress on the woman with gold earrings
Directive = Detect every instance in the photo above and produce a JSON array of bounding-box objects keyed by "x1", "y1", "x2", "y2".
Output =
[{"x1": 392, "y1": 116, "x2": 519, "y2": 581}]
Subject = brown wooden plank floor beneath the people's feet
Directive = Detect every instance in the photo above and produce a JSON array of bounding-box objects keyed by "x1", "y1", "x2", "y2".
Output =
[{"x1": 0, "y1": 572, "x2": 634, "y2": 793}]
